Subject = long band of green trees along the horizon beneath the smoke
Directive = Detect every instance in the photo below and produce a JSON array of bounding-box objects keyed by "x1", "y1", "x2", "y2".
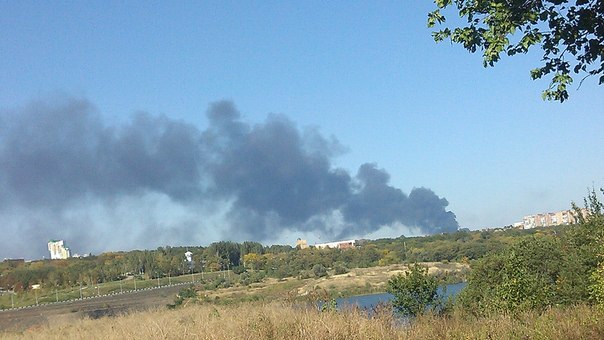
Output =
[{"x1": 0, "y1": 220, "x2": 564, "y2": 292}]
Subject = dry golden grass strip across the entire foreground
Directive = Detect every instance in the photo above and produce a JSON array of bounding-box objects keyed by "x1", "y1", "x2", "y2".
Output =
[{"x1": 0, "y1": 303, "x2": 604, "y2": 339}]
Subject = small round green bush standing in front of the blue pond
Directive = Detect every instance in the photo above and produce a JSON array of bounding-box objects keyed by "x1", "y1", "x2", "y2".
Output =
[{"x1": 388, "y1": 263, "x2": 439, "y2": 316}]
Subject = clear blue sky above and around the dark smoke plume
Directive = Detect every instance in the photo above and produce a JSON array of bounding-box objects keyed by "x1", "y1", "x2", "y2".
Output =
[{"x1": 0, "y1": 1, "x2": 604, "y2": 256}]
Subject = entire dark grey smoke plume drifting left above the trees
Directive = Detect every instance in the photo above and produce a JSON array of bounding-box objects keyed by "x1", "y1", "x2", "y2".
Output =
[{"x1": 0, "y1": 99, "x2": 458, "y2": 258}]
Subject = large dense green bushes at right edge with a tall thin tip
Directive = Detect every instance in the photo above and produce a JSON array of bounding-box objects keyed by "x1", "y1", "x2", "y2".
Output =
[{"x1": 460, "y1": 190, "x2": 604, "y2": 314}]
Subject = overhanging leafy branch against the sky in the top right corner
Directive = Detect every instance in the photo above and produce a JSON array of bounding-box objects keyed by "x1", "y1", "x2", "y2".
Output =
[{"x1": 428, "y1": 0, "x2": 604, "y2": 102}]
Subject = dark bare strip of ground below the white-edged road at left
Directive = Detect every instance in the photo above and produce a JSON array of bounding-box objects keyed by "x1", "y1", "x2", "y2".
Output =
[{"x1": 0, "y1": 285, "x2": 187, "y2": 331}]
